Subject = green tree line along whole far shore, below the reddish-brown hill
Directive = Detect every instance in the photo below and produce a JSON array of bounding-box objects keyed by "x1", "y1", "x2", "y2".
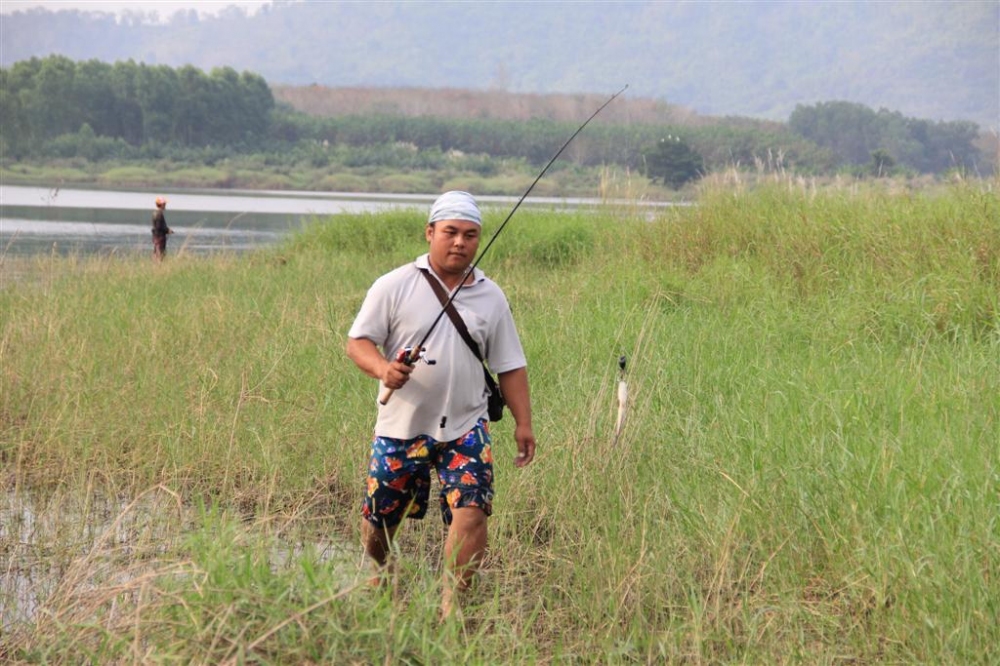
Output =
[{"x1": 0, "y1": 56, "x2": 981, "y2": 187}]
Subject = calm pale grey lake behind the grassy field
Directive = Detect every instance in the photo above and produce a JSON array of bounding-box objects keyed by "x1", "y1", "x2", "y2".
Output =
[{"x1": 0, "y1": 185, "x2": 640, "y2": 256}]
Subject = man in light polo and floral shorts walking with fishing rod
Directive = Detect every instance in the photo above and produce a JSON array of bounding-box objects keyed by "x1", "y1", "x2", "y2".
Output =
[{"x1": 347, "y1": 191, "x2": 535, "y2": 617}]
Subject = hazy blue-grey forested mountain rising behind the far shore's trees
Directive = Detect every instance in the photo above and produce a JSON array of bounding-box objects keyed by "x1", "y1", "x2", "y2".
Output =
[{"x1": 0, "y1": 0, "x2": 1000, "y2": 129}]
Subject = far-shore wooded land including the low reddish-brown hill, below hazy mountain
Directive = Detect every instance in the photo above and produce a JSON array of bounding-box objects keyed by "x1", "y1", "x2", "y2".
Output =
[{"x1": 0, "y1": 56, "x2": 996, "y2": 192}]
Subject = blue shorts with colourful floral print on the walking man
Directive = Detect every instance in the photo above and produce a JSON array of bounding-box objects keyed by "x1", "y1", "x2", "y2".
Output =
[{"x1": 361, "y1": 419, "x2": 493, "y2": 527}]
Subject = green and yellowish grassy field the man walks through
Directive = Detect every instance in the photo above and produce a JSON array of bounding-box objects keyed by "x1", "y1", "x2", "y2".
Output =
[{"x1": 0, "y1": 181, "x2": 1000, "y2": 664}]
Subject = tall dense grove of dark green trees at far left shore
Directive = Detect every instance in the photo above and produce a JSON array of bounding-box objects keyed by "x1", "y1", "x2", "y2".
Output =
[{"x1": 0, "y1": 55, "x2": 275, "y2": 156}]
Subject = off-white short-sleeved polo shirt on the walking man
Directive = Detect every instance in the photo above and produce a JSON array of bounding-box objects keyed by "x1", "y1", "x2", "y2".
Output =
[{"x1": 347, "y1": 254, "x2": 527, "y2": 441}]
